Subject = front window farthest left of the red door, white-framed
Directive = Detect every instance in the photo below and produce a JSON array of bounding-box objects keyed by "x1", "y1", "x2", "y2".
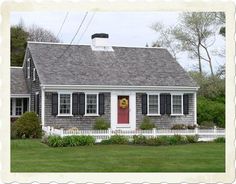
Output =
[{"x1": 58, "y1": 93, "x2": 72, "y2": 116}]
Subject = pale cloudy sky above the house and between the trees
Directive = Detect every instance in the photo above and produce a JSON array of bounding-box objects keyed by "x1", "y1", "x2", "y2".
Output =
[{"x1": 10, "y1": 11, "x2": 225, "y2": 72}]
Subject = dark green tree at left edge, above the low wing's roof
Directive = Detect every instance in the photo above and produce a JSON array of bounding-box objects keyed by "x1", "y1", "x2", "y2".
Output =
[{"x1": 11, "y1": 24, "x2": 28, "y2": 66}]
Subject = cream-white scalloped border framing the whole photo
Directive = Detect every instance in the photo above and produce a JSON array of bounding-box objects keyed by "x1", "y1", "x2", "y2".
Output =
[{"x1": 0, "y1": 0, "x2": 236, "y2": 184}]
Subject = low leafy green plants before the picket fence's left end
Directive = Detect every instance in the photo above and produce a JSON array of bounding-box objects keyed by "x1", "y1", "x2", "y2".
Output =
[{"x1": 46, "y1": 135, "x2": 95, "y2": 147}]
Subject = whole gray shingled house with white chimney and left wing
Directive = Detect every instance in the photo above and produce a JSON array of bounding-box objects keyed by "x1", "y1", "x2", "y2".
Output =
[{"x1": 11, "y1": 33, "x2": 198, "y2": 130}]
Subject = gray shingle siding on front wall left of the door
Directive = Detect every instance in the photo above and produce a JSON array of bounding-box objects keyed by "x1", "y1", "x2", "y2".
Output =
[{"x1": 45, "y1": 92, "x2": 111, "y2": 130}]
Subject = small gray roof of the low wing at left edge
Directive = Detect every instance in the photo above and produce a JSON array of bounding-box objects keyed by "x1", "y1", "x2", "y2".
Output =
[{"x1": 11, "y1": 68, "x2": 28, "y2": 94}]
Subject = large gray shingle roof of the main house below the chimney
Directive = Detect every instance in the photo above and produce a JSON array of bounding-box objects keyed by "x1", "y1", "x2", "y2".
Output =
[{"x1": 28, "y1": 42, "x2": 197, "y2": 87}]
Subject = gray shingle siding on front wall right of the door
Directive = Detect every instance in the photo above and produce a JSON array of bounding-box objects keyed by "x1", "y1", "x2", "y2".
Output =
[{"x1": 136, "y1": 93, "x2": 194, "y2": 129}]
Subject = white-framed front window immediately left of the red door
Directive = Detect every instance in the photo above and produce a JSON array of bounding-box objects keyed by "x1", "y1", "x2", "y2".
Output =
[{"x1": 85, "y1": 94, "x2": 98, "y2": 115}]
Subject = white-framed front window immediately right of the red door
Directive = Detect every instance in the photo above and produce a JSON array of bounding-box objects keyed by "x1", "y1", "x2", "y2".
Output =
[{"x1": 147, "y1": 94, "x2": 160, "y2": 115}]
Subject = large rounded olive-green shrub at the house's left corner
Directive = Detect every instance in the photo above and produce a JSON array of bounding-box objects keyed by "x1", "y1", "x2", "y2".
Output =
[{"x1": 12, "y1": 112, "x2": 42, "y2": 138}]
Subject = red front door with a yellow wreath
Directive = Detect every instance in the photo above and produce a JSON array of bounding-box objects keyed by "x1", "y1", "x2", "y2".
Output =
[{"x1": 118, "y1": 96, "x2": 129, "y2": 124}]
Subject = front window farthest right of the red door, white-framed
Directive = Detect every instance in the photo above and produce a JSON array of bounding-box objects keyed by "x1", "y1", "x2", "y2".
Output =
[{"x1": 171, "y1": 94, "x2": 183, "y2": 115}]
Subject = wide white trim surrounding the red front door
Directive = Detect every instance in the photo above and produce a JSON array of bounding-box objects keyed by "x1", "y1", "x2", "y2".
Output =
[{"x1": 111, "y1": 91, "x2": 136, "y2": 130}]
